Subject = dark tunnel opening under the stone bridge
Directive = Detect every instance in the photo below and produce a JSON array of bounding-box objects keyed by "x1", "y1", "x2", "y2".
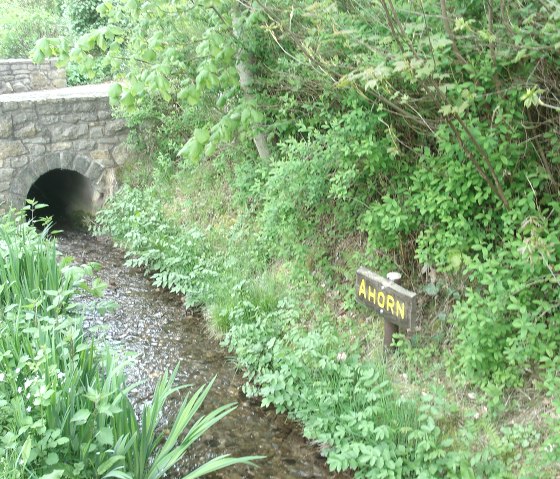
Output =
[{"x1": 27, "y1": 169, "x2": 93, "y2": 228}]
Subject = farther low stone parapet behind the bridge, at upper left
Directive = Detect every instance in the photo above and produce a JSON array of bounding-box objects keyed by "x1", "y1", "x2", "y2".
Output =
[{"x1": 0, "y1": 59, "x2": 66, "y2": 95}]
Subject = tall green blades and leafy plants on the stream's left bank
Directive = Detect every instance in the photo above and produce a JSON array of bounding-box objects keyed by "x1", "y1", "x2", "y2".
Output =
[{"x1": 0, "y1": 214, "x2": 262, "y2": 479}]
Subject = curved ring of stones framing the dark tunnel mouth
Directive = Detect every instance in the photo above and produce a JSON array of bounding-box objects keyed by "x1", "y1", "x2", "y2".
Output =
[{"x1": 11, "y1": 151, "x2": 106, "y2": 209}]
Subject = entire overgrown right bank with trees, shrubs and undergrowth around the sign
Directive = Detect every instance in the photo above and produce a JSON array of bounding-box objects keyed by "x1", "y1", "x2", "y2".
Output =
[{"x1": 26, "y1": 0, "x2": 560, "y2": 478}]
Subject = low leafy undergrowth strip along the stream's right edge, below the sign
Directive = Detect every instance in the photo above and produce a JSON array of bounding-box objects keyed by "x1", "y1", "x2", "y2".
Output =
[{"x1": 95, "y1": 169, "x2": 558, "y2": 478}]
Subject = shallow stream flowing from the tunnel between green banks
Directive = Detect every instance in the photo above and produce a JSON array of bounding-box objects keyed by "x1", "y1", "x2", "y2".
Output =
[{"x1": 57, "y1": 232, "x2": 349, "y2": 479}]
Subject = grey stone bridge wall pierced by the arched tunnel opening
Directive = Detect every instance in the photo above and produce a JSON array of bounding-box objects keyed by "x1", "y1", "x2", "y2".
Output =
[{"x1": 0, "y1": 85, "x2": 128, "y2": 209}]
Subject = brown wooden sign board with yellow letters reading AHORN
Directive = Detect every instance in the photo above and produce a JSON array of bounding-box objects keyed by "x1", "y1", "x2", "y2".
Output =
[{"x1": 356, "y1": 268, "x2": 416, "y2": 332}]
